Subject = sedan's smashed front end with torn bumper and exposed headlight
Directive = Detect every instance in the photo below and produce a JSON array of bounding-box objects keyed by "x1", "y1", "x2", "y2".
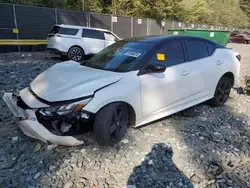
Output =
[{"x1": 3, "y1": 88, "x2": 93, "y2": 146}]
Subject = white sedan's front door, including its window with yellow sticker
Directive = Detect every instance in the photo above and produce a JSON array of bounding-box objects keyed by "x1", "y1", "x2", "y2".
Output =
[{"x1": 139, "y1": 40, "x2": 192, "y2": 118}]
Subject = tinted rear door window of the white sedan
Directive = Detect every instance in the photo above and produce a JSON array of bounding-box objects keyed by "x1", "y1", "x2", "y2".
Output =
[{"x1": 186, "y1": 40, "x2": 209, "y2": 61}]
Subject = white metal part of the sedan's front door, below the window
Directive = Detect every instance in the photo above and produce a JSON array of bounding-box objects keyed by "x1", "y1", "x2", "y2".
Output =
[{"x1": 139, "y1": 63, "x2": 191, "y2": 116}]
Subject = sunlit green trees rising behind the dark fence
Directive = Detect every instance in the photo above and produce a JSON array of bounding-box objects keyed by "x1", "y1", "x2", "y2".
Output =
[{"x1": 0, "y1": 0, "x2": 250, "y2": 27}]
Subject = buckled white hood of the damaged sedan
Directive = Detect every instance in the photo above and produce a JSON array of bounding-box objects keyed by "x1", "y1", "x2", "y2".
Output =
[{"x1": 30, "y1": 61, "x2": 123, "y2": 102}]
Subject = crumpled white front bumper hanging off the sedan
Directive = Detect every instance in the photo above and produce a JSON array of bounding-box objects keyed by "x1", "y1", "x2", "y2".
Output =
[{"x1": 3, "y1": 93, "x2": 83, "y2": 146}]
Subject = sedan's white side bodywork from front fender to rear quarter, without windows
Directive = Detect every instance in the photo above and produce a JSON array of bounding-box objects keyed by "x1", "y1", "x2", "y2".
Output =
[{"x1": 84, "y1": 49, "x2": 240, "y2": 127}]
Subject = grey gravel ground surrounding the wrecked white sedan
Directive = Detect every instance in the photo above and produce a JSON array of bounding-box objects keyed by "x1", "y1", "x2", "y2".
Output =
[{"x1": 0, "y1": 44, "x2": 250, "y2": 188}]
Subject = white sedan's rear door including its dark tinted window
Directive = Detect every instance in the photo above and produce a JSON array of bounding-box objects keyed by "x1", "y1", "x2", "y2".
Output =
[{"x1": 185, "y1": 39, "x2": 224, "y2": 100}]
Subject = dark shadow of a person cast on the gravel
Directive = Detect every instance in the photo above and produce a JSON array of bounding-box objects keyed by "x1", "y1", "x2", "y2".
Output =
[{"x1": 127, "y1": 143, "x2": 194, "y2": 188}]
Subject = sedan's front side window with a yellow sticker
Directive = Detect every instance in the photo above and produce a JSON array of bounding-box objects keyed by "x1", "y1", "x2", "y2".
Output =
[{"x1": 146, "y1": 40, "x2": 185, "y2": 67}]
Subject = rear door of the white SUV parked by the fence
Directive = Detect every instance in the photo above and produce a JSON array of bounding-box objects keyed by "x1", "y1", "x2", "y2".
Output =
[{"x1": 82, "y1": 29, "x2": 105, "y2": 54}]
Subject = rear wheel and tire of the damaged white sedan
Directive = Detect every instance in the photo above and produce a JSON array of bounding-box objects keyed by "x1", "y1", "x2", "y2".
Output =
[{"x1": 209, "y1": 76, "x2": 233, "y2": 107}]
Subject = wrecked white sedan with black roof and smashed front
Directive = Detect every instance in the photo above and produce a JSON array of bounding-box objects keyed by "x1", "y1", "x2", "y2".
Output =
[{"x1": 3, "y1": 36, "x2": 241, "y2": 146}]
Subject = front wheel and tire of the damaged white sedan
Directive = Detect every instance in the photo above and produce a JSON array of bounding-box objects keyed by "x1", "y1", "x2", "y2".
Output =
[{"x1": 94, "y1": 103, "x2": 129, "y2": 146}]
